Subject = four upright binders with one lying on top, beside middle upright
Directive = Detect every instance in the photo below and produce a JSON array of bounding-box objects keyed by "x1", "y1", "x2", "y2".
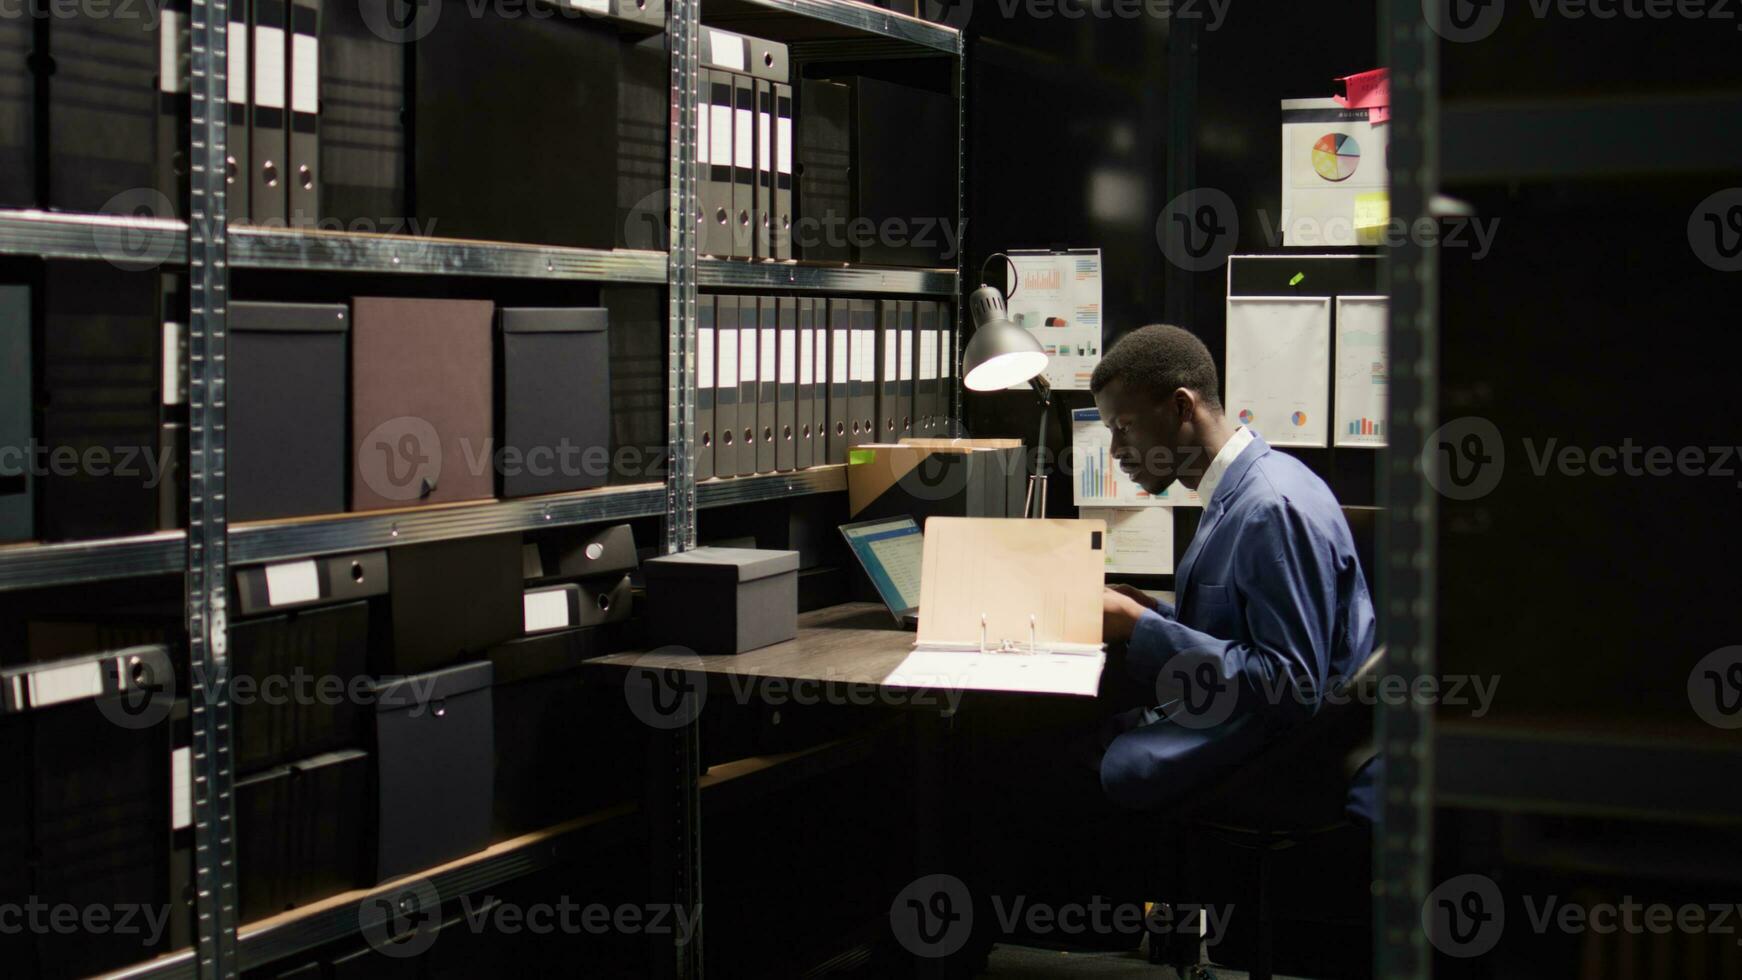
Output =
[{"x1": 695, "y1": 28, "x2": 794, "y2": 259}]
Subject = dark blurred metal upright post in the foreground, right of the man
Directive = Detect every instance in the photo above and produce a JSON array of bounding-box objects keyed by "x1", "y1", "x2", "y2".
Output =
[{"x1": 1373, "y1": 0, "x2": 1439, "y2": 980}]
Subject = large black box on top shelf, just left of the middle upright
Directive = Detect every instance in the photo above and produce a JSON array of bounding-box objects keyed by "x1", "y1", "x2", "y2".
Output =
[{"x1": 411, "y1": 0, "x2": 625, "y2": 249}]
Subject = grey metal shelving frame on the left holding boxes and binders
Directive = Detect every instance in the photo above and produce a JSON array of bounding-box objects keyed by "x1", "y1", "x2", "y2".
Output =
[{"x1": 0, "y1": 0, "x2": 965, "y2": 978}]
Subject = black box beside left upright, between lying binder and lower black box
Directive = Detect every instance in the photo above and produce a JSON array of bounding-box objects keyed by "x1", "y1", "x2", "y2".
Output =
[{"x1": 230, "y1": 602, "x2": 369, "y2": 773}]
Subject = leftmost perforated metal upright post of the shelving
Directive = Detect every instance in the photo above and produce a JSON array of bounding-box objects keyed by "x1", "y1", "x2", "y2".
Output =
[{"x1": 185, "y1": 0, "x2": 240, "y2": 980}]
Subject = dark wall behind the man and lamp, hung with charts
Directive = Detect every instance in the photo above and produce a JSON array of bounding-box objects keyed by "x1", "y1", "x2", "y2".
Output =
[{"x1": 963, "y1": 0, "x2": 1378, "y2": 529}]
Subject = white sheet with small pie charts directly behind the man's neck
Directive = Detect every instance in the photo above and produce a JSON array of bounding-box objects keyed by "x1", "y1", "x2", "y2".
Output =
[{"x1": 1225, "y1": 296, "x2": 1331, "y2": 447}]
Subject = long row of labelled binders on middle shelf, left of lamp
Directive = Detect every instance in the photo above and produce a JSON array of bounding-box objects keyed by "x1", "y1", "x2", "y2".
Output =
[{"x1": 693, "y1": 294, "x2": 955, "y2": 480}]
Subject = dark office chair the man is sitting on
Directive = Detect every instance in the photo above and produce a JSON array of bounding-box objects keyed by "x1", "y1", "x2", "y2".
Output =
[{"x1": 1150, "y1": 646, "x2": 1385, "y2": 980}]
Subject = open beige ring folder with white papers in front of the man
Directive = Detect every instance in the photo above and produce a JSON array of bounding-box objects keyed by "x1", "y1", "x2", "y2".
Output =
[{"x1": 883, "y1": 517, "x2": 1106, "y2": 698}]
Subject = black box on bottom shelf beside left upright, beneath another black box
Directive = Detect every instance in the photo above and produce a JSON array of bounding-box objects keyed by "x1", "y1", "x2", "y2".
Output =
[{"x1": 235, "y1": 748, "x2": 369, "y2": 921}]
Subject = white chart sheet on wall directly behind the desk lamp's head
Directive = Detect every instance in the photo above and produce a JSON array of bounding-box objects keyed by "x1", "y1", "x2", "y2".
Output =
[{"x1": 1005, "y1": 249, "x2": 1101, "y2": 392}]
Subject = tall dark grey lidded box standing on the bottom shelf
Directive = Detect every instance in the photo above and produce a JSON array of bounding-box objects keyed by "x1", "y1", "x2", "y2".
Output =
[{"x1": 375, "y1": 661, "x2": 493, "y2": 881}]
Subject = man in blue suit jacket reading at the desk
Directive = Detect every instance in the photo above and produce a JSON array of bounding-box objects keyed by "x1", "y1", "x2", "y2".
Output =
[{"x1": 1090, "y1": 326, "x2": 1374, "y2": 816}]
